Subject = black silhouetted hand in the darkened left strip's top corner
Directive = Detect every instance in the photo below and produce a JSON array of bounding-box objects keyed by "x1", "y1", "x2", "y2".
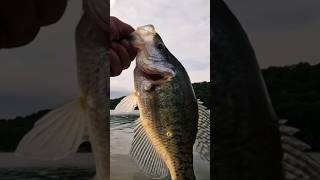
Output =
[{"x1": 0, "y1": 0, "x2": 67, "y2": 49}]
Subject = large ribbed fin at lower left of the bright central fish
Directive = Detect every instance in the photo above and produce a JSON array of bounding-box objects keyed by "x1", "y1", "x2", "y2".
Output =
[{"x1": 129, "y1": 119, "x2": 168, "y2": 179}]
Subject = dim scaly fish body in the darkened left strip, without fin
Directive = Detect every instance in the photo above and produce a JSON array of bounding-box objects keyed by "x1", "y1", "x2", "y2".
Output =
[{"x1": 76, "y1": 13, "x2": 110, "y2": 180}]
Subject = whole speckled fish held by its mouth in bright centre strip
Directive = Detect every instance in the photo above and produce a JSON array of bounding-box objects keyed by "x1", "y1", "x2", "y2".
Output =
[{"x1": 115, "y1": 24, "x2": 210, "y2": 180}]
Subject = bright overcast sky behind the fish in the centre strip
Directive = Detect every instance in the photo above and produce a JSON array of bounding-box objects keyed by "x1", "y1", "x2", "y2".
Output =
[{"x1": 110, "y1": 0, "x2": 210, "y2": 96}]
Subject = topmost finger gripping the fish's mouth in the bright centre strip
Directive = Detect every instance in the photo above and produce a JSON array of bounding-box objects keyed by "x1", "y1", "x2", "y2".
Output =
[{"x1": 110, "y1": 16, "x2": 134, "y2": 41}]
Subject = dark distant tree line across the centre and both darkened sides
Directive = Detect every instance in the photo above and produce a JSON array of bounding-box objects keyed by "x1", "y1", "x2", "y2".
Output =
[{"x1": 0, "y1": 63, "x2": 320, "y2": 152}]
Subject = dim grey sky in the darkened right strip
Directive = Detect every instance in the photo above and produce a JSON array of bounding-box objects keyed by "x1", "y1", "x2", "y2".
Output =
[{"x1": 224, "y1": 0, "x2": 320, "y2": 68}]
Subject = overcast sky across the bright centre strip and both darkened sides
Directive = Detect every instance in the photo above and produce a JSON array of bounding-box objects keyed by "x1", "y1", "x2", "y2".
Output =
[{"x1": 0, "y1": 0, "x2": 320, "y2": 118}]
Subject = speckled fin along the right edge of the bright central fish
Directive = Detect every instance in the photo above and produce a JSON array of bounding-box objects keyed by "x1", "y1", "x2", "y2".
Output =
[{"x1": 194, "y1": 99, "x2": 210, "y2": 161}]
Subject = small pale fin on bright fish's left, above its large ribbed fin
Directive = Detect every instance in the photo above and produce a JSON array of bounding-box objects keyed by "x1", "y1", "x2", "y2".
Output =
[{"x1": 114, "y1": 92, "x2": 138, "y2": 112}]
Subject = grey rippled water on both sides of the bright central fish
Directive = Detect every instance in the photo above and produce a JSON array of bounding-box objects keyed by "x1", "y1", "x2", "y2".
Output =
[{"x1": 110, "y1": 112, "x2": 210, "y2": 180}]
